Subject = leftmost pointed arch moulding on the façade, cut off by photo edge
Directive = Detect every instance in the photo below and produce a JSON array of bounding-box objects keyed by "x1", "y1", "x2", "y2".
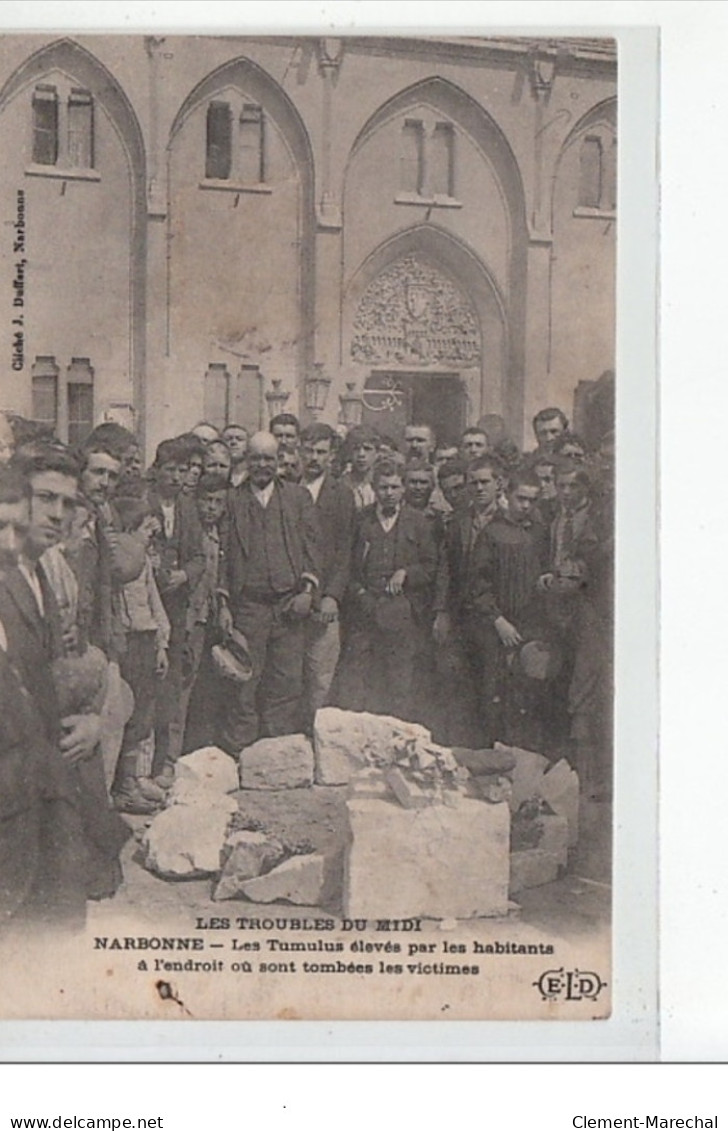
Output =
[{"x1": 0, "y1": 38, "x2": 147, "y2": 442}]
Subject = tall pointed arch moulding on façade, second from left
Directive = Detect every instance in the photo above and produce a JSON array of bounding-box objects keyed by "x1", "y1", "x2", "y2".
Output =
[{"x1": 166, "y1": 58, "x2": 315, "y2": 395}]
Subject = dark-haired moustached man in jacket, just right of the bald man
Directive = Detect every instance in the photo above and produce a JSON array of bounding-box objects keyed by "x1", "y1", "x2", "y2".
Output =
[{"x1": 301, "y1": 424, "x2": 356, "y2": 718}]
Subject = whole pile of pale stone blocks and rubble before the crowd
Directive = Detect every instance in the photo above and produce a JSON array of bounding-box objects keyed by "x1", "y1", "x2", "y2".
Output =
[{"x1": 141, "y1": 707, "x2": 579, "y2": 920}]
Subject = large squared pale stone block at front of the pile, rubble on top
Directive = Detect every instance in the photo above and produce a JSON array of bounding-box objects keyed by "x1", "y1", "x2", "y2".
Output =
[{"x1": 344, "y1": 797, "x2": 510, "y2": 920}]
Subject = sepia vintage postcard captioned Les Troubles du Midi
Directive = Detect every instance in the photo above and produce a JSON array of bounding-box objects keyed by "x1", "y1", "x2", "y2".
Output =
[{"x1": 0, "y1": 33, "x2": 619, "y2": 1022}]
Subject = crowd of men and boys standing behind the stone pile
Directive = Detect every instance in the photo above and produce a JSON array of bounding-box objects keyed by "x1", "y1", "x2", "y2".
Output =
[{"x1": 0, "y1": 408, "x2": 614, "y2": 923}]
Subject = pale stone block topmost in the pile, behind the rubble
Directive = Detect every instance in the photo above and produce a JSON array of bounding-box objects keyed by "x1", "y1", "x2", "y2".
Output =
[{"x1": 313, "y1": 707, "x2": 432, "y2": 785}]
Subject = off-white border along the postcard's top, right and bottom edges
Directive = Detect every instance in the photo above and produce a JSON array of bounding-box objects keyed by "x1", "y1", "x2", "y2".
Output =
[{"x1": 0, "y1": 0, "x2": 664, "y2": 1061}]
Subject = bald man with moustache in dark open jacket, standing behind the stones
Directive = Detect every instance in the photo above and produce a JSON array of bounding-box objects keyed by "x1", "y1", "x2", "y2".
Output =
[{"x1": 219, "y1": 432, "x2": 320, "y2": 754}]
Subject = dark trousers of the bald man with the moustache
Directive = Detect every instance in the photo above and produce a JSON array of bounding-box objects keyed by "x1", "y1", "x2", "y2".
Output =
[{"x1": 219, "y1": 595, "x2": 305, "y2": 754}]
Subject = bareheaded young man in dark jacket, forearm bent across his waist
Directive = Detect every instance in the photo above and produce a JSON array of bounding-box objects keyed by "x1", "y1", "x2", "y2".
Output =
[{"x1": 340, "y1": 458, "x2": 437, "y2": 719}]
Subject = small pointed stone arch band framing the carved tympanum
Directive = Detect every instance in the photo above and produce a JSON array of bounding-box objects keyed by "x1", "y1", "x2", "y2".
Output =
[{"x1": 343, "y1": 224, "x2": 508, "y2": 436}]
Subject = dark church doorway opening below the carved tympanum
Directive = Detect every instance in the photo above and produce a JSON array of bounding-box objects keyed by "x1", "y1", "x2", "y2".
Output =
[{"x1": 363, "y1": 370, "x2": 467, "y2": 444}]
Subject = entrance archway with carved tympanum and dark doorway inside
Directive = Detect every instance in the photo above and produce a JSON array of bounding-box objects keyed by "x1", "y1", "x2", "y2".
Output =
[{"x1": 344, "y1": 227, "x2": 509, "y2": 437}]
